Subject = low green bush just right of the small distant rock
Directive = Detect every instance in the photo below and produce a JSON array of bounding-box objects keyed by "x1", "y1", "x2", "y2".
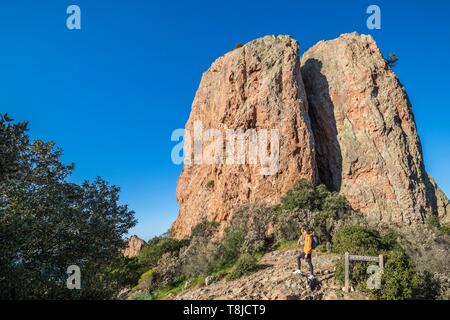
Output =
[{"x1": 138, "y1": 235, "x2": 189, "y2": 269}]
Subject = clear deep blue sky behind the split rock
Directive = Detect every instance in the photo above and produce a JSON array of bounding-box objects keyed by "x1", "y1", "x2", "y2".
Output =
[{"x1": 0, "y1": 0, "x2": 450, "y2": 239}]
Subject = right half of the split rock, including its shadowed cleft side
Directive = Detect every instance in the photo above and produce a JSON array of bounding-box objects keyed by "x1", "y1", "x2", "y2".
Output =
[{"x1": 301, "y1": 33, "x2": 436, "y2": 224}]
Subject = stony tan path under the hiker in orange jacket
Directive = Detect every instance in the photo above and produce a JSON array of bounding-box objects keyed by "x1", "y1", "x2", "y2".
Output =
[{"x1": 172, "y1": 250, "x2": 364, "y2": 300}]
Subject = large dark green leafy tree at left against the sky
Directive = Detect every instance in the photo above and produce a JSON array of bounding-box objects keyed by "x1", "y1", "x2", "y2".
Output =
[{"x1": 0, "y1": 115, "x2": 136, "y2": 299}]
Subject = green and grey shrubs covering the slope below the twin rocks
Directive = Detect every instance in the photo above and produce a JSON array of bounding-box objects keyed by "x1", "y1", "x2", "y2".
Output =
[{"x1": 128, "y1": 180, "x2": 448, "y2": 299}]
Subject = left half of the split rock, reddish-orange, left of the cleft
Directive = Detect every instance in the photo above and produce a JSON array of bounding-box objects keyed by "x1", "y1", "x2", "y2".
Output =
[{"x1": 172, "y1": 36, "x2": 316, "y2": 238}]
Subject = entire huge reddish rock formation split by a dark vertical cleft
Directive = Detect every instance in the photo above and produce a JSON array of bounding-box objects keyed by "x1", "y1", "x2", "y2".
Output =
[{"x1": 172, "y1": 33, "x2": 450, "y2": 238}]
